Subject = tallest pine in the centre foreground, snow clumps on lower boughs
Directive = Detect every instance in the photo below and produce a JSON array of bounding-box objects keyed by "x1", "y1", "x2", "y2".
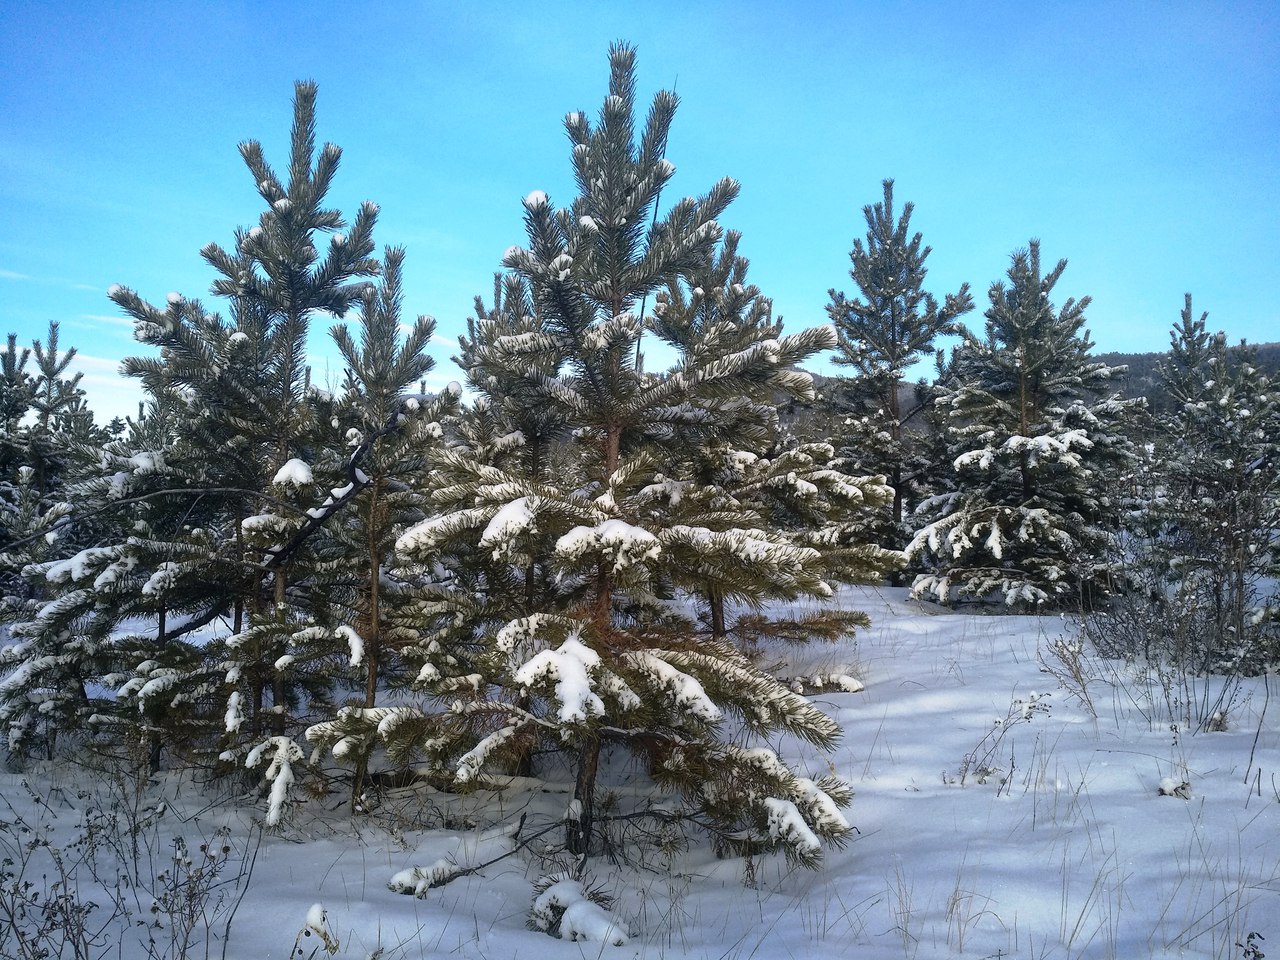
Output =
[{"x1": 348, "y1": 45, "x2": 884, "y2": 863}]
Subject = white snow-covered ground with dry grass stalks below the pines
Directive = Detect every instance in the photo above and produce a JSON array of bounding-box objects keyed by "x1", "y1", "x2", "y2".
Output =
[{"x1": 0, "y1": 590, "x2": 1280, "y2": 960}]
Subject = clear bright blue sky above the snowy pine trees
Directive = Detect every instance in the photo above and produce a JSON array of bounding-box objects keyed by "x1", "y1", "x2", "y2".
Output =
[{"x1": 0, "y1": 0, "x2": 1280, "y2": 420}]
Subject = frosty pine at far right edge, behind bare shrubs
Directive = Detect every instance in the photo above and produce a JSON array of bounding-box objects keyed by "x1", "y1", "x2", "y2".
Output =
[{"x1": 1144, "y1": 293, "x2": 1280, "y2": 672}]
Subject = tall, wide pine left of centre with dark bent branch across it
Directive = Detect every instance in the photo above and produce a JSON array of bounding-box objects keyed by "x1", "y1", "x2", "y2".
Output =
[{"x1": 5, "y1": 83, "x2": 450, "y2": 788}]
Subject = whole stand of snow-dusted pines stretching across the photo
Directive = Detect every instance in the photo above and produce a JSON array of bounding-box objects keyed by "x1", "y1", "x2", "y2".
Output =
[{"x1": 0, "y1": 44, "x2": 1280, "y2": 901}]
